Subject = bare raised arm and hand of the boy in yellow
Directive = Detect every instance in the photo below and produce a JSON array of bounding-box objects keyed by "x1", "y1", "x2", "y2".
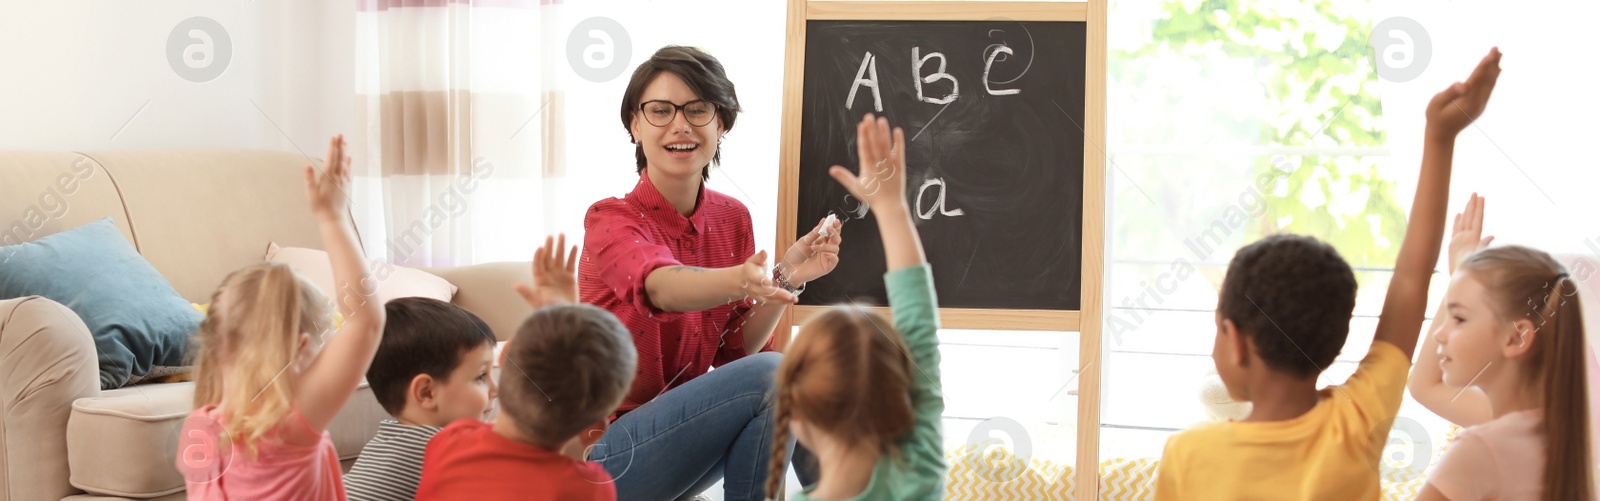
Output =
[{"x1": 1373, "y1": 50, "x2": 1501, "y2": 359}]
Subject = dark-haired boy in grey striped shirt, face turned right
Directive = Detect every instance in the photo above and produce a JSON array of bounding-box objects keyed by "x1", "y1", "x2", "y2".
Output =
[{"x1": 344, "y1": 298, "x2": 498, "y2": 501}]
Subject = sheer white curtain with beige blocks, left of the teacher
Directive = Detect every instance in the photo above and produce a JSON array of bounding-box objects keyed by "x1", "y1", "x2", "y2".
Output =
[{"x1": 349, "y1": 0, "x2": 565, "y2": 266}]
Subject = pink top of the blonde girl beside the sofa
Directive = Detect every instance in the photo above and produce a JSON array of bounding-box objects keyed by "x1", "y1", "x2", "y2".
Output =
[{"x1": 176, "y1": 405, "x2": 344, "y2": 501}]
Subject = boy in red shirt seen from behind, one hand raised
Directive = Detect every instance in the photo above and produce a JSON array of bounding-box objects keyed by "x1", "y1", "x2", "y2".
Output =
[{"x1": 416, "y1": 238, "x2": 638, "y2": 501}]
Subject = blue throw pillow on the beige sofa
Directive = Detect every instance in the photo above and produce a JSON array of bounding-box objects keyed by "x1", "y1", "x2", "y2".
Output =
[{"x1": 0, "y1": 218, "x2": 203, "y2": 389}]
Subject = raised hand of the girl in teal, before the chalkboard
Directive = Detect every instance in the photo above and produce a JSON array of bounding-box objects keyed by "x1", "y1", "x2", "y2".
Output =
[{"x1": 827, "y1": 114, "x2": 906, "y2": 210}]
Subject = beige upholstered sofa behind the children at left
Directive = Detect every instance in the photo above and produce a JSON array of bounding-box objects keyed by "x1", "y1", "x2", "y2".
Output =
[{"x1": 0, "y1": 150, "x2": 530, "y2": 501}]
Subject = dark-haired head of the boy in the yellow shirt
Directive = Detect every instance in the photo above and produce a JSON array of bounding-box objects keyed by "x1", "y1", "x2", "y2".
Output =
[{"x1": 1218, "y1": 235, "x2": 1355, "y2": 377}]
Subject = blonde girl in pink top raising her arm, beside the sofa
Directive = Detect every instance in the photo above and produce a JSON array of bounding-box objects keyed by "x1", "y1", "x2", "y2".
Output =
[{"x1": 176, "y1": 136, "x2": 384, "y2": 501}]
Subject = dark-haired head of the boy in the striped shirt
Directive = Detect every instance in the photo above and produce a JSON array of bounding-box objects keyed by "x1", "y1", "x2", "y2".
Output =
[{"x1": 366, "y1": 298, "x2": 496, "y2": 426}]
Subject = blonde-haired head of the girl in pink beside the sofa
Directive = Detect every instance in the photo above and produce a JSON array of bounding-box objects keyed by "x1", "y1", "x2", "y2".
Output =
[{"x1": 194, "y1": 263, "x2": 333, "y2": 450}]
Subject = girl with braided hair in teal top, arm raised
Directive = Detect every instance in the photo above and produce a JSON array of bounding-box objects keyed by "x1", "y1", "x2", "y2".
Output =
[{"x1": 766, "y1": 114, "x2": 946, "y2": 499}]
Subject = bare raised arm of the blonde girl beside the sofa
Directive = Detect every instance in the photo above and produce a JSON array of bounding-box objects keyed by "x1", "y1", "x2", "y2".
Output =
[{"x1": 294, "y1": 136, "x2": 384, "y2": 432}]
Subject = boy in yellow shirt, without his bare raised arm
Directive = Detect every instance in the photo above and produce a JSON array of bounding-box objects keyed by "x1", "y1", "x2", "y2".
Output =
[{"x1": 1157, "y1": 235, "x2": 1410, "y2": 499}]
